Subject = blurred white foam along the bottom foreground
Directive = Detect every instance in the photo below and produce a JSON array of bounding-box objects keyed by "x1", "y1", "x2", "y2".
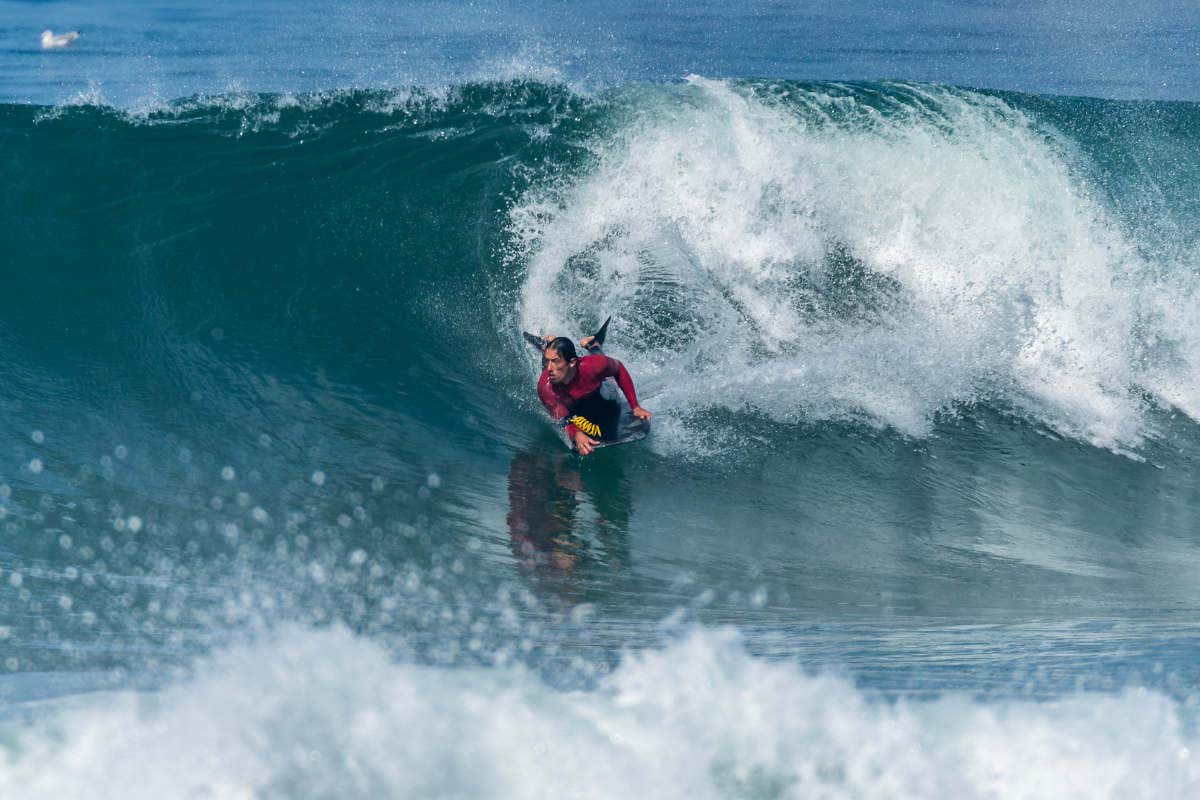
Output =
[{"x1": 0, "y1": 630, "x2": 1200, "y2": 800}]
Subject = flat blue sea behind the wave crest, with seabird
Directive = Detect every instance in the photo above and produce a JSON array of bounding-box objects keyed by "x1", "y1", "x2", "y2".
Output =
[{"x1": 7, "y1": 0, "x2": 1200, "y2": 108}]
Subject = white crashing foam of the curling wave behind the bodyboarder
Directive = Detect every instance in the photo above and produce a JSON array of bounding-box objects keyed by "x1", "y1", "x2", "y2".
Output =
[{"x1": 511, "y1": 77, "x2": 1200, "y2": 450}]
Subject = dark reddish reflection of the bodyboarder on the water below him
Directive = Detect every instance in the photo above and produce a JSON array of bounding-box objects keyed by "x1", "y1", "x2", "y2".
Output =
[{"x1": 506, "y1": 445, "x2": 630, "y2": 604}]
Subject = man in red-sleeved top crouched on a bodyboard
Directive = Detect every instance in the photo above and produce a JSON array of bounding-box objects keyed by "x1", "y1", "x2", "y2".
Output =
[{"x1": 538, "y1": 336, "x2": 653, "y2": 456}]
